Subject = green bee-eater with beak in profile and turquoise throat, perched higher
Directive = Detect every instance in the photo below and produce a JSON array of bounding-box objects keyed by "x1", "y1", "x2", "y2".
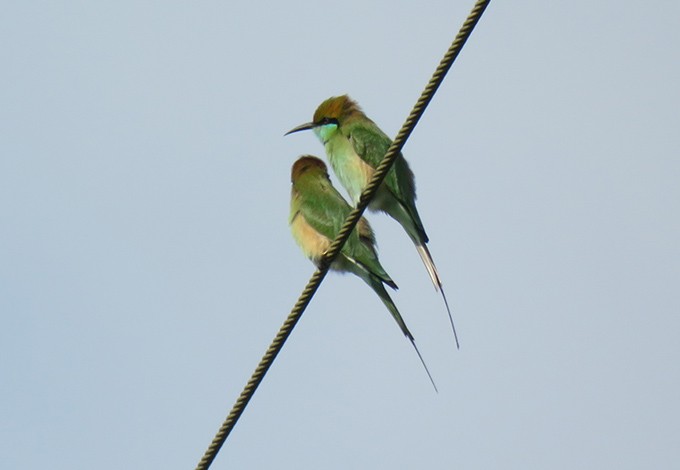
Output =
[{"x1": 286, "y1": 95, "x2": 459, "y2": 347}]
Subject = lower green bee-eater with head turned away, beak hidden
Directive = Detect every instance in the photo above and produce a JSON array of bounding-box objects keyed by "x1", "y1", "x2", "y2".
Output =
[{"x1": 288, "y1": 155, "x2": 437, "y2": 390}]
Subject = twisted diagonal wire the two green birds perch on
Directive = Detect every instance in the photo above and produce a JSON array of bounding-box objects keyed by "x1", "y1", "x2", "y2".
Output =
[{"x1": 196, "y1": 0, "x2": 490, "y2": 470}]
